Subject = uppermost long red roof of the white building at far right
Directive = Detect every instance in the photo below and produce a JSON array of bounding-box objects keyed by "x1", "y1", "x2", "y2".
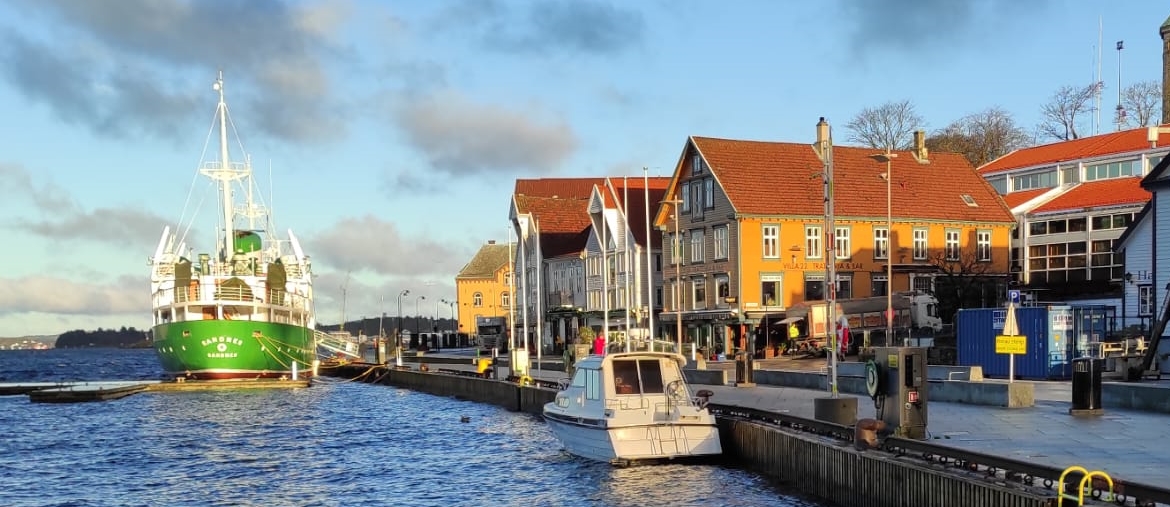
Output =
[{"x1": 979, "y1": 128, "x2": 1170, "y2": 176}]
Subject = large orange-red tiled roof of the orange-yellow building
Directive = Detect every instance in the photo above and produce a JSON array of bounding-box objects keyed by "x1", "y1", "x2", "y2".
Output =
[{"x1": 672, "y1": 137, "x2": 1014, "y2": 222}]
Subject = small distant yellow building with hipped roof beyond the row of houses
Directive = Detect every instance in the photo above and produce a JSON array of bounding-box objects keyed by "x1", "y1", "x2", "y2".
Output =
[{"x1": 455, "y1": 241, "x2": 515, "y2": 335}]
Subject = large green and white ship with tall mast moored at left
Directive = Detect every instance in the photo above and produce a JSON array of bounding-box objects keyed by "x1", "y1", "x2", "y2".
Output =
[{"x1": 150, "y1": 73, "x2": 317, "y2": 379}]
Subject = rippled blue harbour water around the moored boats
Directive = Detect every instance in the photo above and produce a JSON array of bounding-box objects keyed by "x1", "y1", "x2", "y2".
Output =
[{"x1": 0, "y1": 350, "x2": 821, "y2": 507}]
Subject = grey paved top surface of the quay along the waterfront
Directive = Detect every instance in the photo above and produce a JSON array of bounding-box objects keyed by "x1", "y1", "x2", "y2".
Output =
[{"x1": 411, "y1": 354, "x2": 1170, "y2": 487}]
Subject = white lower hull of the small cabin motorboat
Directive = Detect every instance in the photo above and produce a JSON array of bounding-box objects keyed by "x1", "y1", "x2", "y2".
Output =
[{"x1": 544, "y1": 406, "x2": 723, "y2": 465}]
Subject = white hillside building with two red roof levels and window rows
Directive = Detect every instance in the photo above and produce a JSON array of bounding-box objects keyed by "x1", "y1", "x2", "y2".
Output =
[{"x1": 979, "y1": 129, "x2": 1170, "y2": 309}]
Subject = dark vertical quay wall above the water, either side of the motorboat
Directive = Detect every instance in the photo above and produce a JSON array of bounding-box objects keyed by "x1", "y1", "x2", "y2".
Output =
[{"x1": 321, "y1": 364, "x2": 1055, "y2": 507}]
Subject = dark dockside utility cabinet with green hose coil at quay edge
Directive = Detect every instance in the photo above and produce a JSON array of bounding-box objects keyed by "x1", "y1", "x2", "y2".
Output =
[{"x1": 866, "y1": 347, "x2": 930, "y2": 439}]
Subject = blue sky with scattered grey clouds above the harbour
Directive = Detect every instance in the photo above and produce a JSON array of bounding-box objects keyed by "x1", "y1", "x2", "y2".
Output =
[{"x1": 0, "y1": 0, "x2": 1170, "y2": 336}]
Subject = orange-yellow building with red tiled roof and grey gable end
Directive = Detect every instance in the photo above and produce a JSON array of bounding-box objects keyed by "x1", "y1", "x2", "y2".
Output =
[{"x1": 655, "y1": 124, "x2": 1016, "y2": 348}]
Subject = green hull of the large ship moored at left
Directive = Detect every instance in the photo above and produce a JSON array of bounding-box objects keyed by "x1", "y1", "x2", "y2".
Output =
[{"x1": 154, "y1": 320, "x2": 317, "y2": 379}]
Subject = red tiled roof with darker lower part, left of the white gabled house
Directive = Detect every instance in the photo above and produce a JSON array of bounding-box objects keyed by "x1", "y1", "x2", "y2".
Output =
[{"x1": 512, "y1": 178, "x2": 604, "y2": 259}]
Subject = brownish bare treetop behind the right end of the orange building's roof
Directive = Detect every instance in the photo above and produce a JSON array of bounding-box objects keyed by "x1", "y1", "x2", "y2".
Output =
[{"x1": 927, "y1": 108, "x2": 1034, "y2": 167}]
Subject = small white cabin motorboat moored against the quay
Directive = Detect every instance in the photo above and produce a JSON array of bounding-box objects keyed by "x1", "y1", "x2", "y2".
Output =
[{"x1": 544, "y1": 351, "x2": 723, "y2": 465}]
